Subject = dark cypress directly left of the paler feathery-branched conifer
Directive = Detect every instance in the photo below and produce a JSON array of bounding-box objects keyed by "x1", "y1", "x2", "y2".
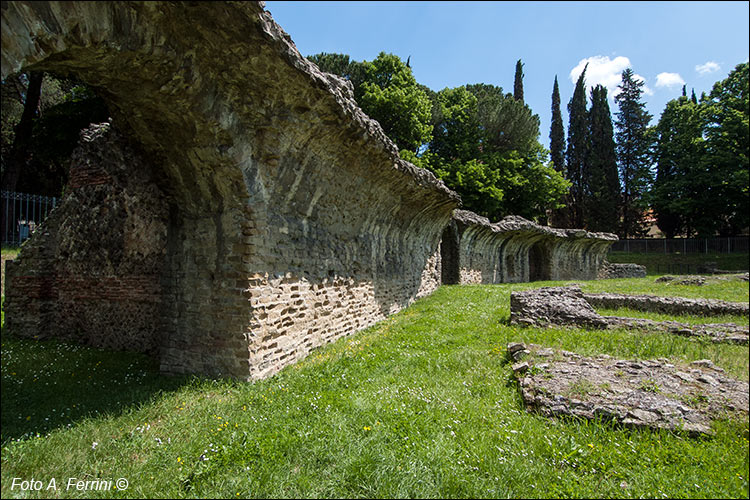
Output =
[{"x1": 586, "y1": 85, "x2": 620, "y2": 232}]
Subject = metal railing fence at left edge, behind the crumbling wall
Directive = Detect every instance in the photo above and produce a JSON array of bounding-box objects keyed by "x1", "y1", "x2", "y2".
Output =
[{"x1": 0, "y1": 191, "x2": 58, "y2": 247}]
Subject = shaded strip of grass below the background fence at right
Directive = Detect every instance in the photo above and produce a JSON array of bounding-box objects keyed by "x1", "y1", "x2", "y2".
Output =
[{"x1": 607, "y1": 252, "x2": 750, "y2": 275}]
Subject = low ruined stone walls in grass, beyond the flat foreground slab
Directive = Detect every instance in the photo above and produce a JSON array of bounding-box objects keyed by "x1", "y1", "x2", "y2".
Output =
[{"x1": 510, "y1": 285, "x2": 748, "y2": 345}]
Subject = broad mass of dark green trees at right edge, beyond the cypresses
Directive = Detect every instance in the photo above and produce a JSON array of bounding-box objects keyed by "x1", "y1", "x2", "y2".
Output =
[{"x1": 650, "y1": 63, "x2": 750, "y2": 238}]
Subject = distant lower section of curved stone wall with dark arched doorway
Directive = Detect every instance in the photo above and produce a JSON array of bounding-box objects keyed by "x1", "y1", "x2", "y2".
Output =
[{"x1": 453, "y1": 210, "x2": 617, "y2": 284}]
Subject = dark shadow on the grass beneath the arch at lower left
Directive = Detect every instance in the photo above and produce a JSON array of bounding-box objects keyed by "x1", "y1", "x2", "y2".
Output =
[{"x1": 1, "y1": 329, "x2": 197, "y2": 444}]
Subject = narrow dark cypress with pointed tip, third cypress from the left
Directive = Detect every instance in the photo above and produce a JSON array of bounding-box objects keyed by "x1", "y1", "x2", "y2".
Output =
[{"x1": 565, "y1": 65, "x2": 589, "y2": 228}]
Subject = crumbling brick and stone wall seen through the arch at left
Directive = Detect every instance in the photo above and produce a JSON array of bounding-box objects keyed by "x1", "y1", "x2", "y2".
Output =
[{"x1": 5, "y1": 123, "x2": 169, "y2": 354}]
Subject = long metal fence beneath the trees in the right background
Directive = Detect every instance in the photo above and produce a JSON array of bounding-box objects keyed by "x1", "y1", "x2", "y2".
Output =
[{"x1": 610, "y1": 236, "x2": 750, "y2": 254}]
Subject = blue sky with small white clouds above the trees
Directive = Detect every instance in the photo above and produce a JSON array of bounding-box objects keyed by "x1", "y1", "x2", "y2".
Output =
[{"x1": 266, "y1": 1, "x2": 750, "y2": 146}]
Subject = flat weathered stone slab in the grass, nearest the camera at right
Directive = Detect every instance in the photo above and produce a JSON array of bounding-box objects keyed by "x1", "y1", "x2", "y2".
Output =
[{"x1": 513, "y1": 346, "x2": 748, "y2": 434}]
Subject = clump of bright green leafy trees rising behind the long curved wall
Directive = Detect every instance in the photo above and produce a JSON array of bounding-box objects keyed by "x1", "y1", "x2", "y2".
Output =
[{"x1": 309, "y1": 53, "x2": 568, "y2": 220}]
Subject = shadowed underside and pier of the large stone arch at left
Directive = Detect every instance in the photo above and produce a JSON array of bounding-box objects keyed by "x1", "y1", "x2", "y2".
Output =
[{"x1": 2, "y1": 2, "x2": 258, "y2": 375}]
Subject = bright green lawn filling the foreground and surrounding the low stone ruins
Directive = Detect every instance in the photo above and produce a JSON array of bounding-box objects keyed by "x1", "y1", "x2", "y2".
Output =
[{"x1": 2, "y1": 277, "x2": 749, "y2": 498}]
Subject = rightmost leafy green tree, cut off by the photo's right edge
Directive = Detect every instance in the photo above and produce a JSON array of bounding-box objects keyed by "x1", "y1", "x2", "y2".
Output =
[{"x1": 696, "y1": 63, "x2": 750, "y2": 236}]
